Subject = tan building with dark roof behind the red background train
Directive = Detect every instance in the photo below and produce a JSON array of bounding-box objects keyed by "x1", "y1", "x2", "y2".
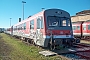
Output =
[{"x1": 71, "y1": 10, "x2": 90, "y2": 22}]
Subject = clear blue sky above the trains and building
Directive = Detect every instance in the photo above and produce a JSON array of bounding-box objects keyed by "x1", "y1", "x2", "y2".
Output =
[{"x1": 0, "y1": 0, "x2": 90, "y2": 28}]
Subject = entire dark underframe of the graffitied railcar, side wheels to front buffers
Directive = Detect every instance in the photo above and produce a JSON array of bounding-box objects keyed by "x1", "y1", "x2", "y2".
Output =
[{"x1": 8, "y1": 35, "x2": 80, "y2": 50}]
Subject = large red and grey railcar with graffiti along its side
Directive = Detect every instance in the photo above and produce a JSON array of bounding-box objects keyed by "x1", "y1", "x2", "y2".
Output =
[{"x1": 8, "y1": 9, "x2": 77, "y2": 47}]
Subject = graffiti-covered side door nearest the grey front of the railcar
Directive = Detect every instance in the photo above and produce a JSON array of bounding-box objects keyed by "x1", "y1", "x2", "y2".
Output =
[{"x1": 36, "y1": 18, "x2": 43, "y2": 46}]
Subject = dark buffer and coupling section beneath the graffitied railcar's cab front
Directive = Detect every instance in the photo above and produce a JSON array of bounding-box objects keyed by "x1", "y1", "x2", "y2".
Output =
[{"x1": 48, "y1": 38, "x2": 80, "y2": 50}]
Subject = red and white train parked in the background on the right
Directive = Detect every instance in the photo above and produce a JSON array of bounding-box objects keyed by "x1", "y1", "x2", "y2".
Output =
[{"x1": 72, "y1": 20, "x2": 90, "y2": 39}]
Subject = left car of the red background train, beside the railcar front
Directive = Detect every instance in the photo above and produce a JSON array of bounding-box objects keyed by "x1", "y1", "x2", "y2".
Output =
[{"x1": 72, "y1": 21, "x2": 84, "y2": 39}]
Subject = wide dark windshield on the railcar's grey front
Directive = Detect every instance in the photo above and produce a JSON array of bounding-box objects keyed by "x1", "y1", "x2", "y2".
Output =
[{"x1": 47, "y1": 16, "x2": 70, "y2": 27}]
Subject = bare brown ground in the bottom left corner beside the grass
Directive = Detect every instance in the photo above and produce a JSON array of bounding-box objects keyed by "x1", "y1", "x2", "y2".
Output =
[{"x1": 0, "y1": 36, "x2": 12, "y2": 60}]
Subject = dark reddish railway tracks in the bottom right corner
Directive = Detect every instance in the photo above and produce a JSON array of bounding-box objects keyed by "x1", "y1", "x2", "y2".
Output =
[{"x1": 61, "y1": 43, "x2": 90, "y2": 60}]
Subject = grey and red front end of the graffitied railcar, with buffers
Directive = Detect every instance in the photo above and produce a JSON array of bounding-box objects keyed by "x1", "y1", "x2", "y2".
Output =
[{"x1": 45, "y1": 9, "x2": 79, "y2": 47}]
